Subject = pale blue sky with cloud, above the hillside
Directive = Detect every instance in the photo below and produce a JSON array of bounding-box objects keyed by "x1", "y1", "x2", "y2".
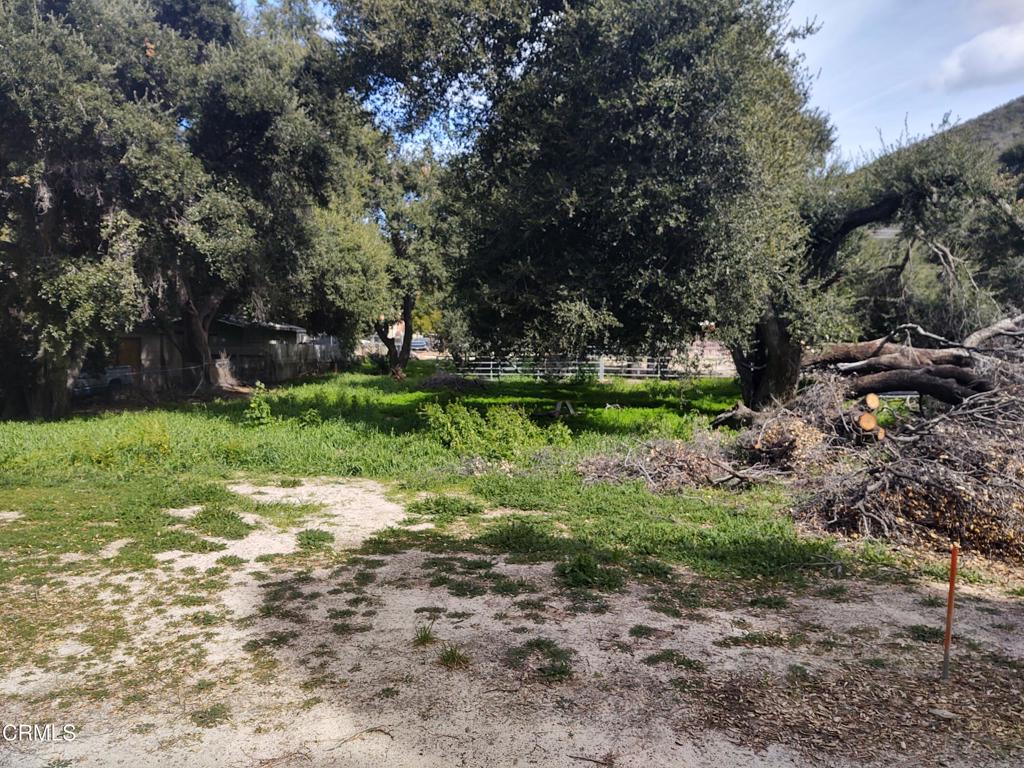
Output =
[{"x1": 792, "y1": 0, "x2": 1024, "y2": 162}]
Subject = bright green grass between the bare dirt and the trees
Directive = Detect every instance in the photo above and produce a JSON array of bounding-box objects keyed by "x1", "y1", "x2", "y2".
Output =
[{"x1": 0, "y1": 366, "x2": 840, "y2": 595}]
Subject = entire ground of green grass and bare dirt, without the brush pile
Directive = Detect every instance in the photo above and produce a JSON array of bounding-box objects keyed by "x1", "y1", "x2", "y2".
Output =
[{"x1": 0, "y1": 368, "x2": 1024, "y2": 768}]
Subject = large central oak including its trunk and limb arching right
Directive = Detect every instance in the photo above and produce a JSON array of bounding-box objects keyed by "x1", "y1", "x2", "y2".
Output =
[{"x1": 340, "y1": 0, "x2": 1015, "y2": 407}]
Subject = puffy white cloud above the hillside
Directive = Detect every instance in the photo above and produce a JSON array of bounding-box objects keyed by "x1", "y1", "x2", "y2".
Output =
[{"x1": 936, "y1": 22, "x2": 1024, "y2": 90}]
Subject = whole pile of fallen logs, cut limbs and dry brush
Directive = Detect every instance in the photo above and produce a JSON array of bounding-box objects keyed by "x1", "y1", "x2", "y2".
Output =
[{"x1": 598, "y1": 315, "x2": 1024, "y2": 561}]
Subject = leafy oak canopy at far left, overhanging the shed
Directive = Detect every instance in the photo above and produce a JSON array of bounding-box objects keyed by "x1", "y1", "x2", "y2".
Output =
[{"x1": 0, "y1": 0, "x2": 362, "y2": 416}]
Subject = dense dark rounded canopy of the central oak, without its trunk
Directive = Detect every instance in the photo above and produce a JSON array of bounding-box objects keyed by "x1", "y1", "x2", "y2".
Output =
[{"x1": 450, "y1": 0, "x2": 827, "y2": 360}]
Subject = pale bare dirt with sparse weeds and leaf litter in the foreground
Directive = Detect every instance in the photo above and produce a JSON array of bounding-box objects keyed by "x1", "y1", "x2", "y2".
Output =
[{"x1": 0, "y1": 480, "x2": 1024, "y2": 768}]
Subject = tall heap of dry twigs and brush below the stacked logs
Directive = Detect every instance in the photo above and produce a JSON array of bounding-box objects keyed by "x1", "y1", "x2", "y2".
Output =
[{"x1": 799, "y1": 392, "x2": 1024, "y2": 560}]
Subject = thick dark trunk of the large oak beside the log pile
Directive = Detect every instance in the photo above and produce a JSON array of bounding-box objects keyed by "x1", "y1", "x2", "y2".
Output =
[{"x1": 730, "y1": 310, "x2": 803, "y2": 411}]
